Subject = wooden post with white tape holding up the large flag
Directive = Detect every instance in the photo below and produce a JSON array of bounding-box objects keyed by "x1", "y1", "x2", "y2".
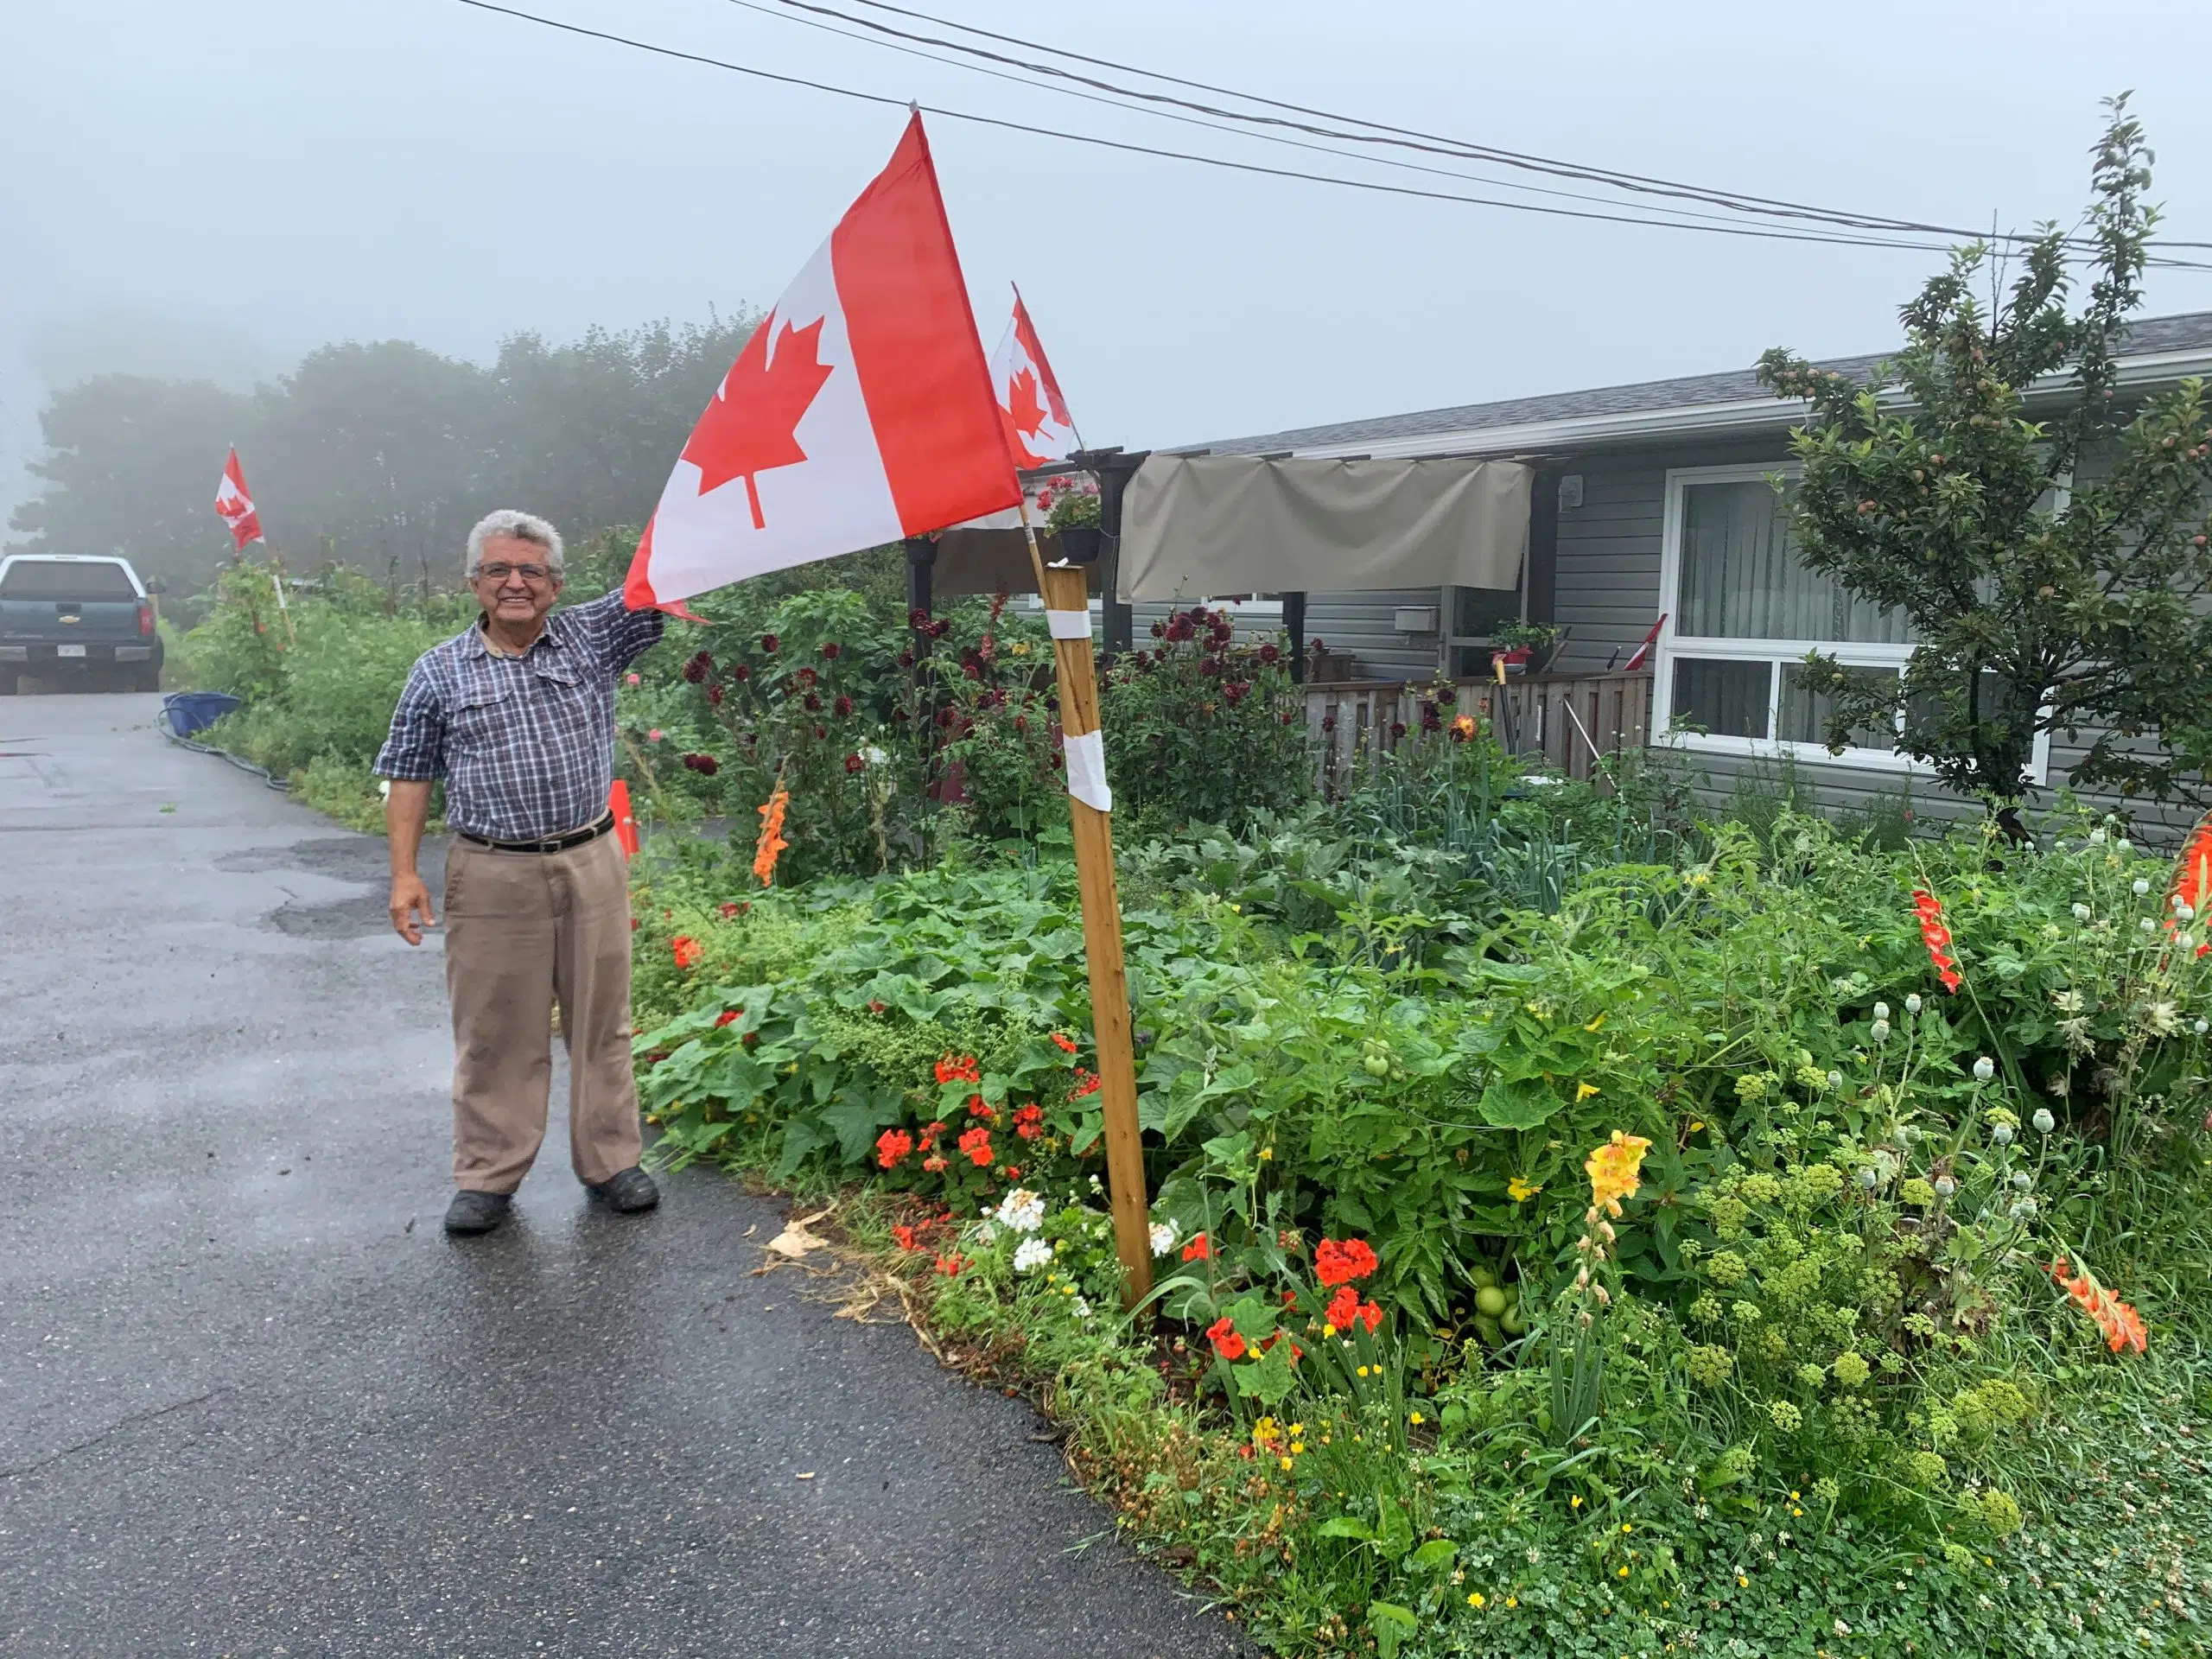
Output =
[{"x1": 1022, "y1": 500, "x2": 1153, "y2": 1307}]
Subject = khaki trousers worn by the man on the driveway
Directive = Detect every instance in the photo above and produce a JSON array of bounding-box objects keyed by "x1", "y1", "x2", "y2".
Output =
[{"x1": 445, "y1": 834, "x2": 641, "y2": 1192}]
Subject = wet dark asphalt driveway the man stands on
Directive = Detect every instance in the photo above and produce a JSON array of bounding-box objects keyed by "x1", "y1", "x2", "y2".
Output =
[{"x1": 0, "y1": 695, "x2": 1245, "y2": 1659}]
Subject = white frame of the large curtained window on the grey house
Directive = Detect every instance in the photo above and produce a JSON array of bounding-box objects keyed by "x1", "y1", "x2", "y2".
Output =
[{"x1": 1652, "y1": 462, "x2": 2050, "y2": 783}]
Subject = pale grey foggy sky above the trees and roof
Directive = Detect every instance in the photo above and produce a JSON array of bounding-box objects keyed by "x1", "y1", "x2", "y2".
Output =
[{"x1": 0, "y1": 0, "x2": 2212, "y2": 505}]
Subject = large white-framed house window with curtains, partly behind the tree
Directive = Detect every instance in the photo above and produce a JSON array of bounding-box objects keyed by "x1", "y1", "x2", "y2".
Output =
[{"x1": 1652, "y1": 467, "x2": 2049, "y2": 781}]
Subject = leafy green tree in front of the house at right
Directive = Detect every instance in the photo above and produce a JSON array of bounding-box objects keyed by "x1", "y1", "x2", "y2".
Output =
[{"x1": 1758, "y1": 98, "x2": 2212, "y2": 825}]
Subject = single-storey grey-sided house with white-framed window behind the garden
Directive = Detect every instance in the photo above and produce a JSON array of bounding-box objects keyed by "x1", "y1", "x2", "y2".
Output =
[{"x1": 1135, "y1": 312, "x2": 2212, "y2": 823}]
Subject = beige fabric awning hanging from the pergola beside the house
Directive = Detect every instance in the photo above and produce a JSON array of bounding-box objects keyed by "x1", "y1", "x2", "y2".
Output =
[{"x1": 1117, "y1": 454, "x2": 1533, "y2": 600}]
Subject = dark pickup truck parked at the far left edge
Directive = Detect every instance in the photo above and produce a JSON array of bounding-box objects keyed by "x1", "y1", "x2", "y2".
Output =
[{"x1": 0, "y1": 553, "x2": 162, "y2": 696}]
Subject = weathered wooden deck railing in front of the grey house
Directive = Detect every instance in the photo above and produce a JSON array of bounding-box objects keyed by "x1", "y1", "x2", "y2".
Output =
[{"x1": 1305, "y1": 672, "x2": 1652, "y2": 791}]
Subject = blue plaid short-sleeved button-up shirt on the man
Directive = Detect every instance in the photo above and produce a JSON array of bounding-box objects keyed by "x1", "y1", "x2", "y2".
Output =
[{"x1": 374, "y1": 588, "x2": 666, "y2": 841}]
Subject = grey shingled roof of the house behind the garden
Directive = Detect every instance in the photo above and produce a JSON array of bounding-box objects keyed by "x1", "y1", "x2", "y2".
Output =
[{"x1": 1170, "y1": 312, "x2": 2212, "y2": 455}]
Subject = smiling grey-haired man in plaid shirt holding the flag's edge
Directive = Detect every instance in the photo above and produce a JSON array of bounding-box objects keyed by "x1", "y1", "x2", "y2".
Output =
[{"x1": 376, "y1": 511, "x2": 664, "y2": 1234}]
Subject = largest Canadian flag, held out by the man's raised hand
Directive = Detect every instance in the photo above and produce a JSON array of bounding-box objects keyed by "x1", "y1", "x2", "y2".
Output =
[{"x1": 624, "y1": 113, "x2": 1022, "y2": 611}]
